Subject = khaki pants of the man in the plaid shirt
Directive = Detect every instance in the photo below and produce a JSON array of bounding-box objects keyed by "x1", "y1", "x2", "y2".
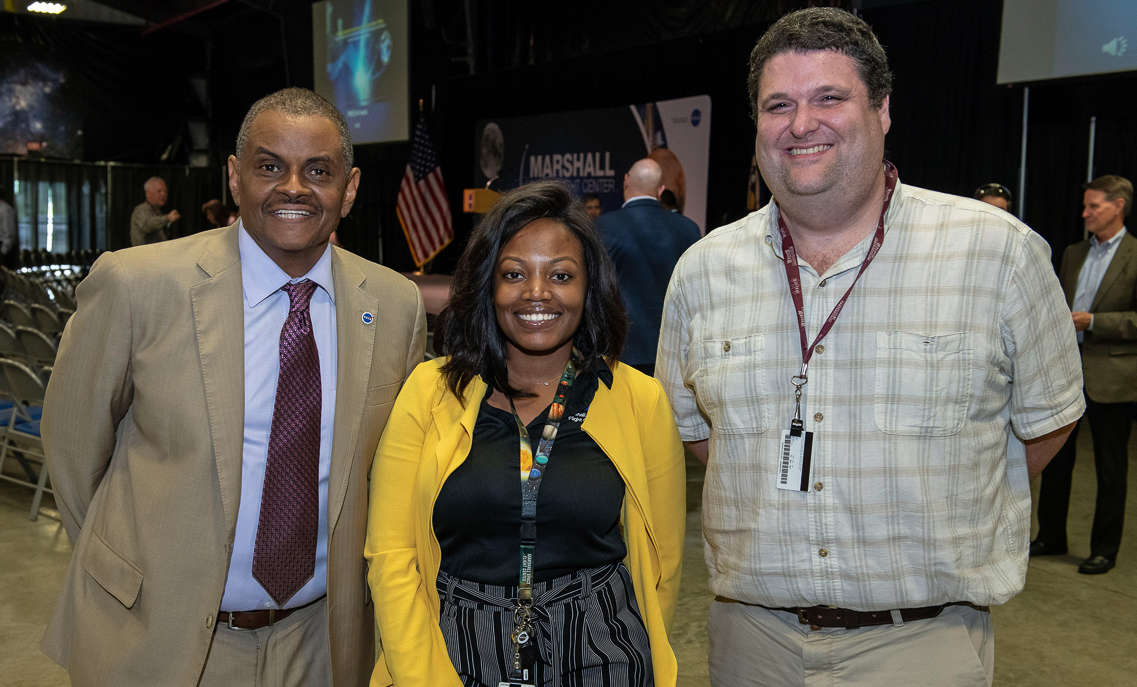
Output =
[{"x1": 707, "y1": 599, "x2": 995, "y2": 687}]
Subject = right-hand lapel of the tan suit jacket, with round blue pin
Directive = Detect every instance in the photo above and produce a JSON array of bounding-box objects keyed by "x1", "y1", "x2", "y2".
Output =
[{"x1": 327, "y1": 248, "x2": 379, "y2": 532}]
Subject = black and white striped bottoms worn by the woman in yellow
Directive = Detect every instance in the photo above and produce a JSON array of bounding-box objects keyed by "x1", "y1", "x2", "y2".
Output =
[{"x1": 438, "y1": 563, "x2": 655, "y2": 687}]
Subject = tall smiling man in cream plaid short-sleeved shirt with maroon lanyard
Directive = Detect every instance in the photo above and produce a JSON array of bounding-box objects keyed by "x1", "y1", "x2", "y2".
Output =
[{"x1": 656, "y1": 8, "x2": 1085, "y2": 687}]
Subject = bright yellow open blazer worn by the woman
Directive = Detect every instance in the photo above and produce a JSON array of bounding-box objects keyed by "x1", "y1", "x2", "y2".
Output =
[{"x1": 364, "y1": 359, "x2": 687, "y2": 687}]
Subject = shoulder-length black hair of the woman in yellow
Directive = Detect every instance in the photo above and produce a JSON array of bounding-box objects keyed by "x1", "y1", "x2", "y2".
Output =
[{"x1": 434, "y1": 181, "x2": 628, "y2": 398}]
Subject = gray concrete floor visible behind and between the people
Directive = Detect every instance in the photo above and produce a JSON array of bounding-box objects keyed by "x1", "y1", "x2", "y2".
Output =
[{"x1": 0, "y1": 431, "x2": 1137, "y2": 687}]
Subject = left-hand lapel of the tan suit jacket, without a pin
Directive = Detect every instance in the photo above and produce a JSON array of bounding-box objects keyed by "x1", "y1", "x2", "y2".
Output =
[{"x1": 190, "y1": 225, "x2": 244, "y2": 541}]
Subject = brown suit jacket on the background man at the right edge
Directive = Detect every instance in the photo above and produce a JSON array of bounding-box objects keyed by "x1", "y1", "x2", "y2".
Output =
[{"x1": 1059, "y1": 232, "x2": 1137, "y2": 403}]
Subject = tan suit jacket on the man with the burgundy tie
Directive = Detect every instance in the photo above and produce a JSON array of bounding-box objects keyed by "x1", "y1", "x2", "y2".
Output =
[{"x1": 41, "y1": 226, "x2": 426, "y2": 687}]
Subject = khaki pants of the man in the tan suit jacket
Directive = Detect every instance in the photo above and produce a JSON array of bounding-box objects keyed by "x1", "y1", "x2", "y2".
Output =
[{"x1": 198, "y1": 598, "x2": 332, "y2": 687}]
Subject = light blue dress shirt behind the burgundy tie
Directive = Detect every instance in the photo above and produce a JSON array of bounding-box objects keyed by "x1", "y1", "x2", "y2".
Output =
[{"x1": 221, "y1": 224, "x2": 335, "y2": 611}]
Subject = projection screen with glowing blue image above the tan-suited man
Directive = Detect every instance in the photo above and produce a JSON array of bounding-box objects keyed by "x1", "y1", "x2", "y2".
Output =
[{"x1": 312, "y1": 0, "x2": 409, "y2": 143}]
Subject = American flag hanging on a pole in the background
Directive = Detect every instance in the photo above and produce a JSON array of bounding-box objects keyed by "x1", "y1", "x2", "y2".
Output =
[{"x1": 395, "y1": 117, "x2": 454, "y2": 267}]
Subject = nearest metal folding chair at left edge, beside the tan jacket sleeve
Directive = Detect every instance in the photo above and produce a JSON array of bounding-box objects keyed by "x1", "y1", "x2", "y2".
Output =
[{"x1": 0, "y1": 358, "x2": 55, "y2": 520}]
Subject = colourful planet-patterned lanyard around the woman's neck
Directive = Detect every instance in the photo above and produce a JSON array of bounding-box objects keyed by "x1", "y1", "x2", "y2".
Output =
[{"x1": 498, "y1": 348, "x2": 580, "y2": 687}]
